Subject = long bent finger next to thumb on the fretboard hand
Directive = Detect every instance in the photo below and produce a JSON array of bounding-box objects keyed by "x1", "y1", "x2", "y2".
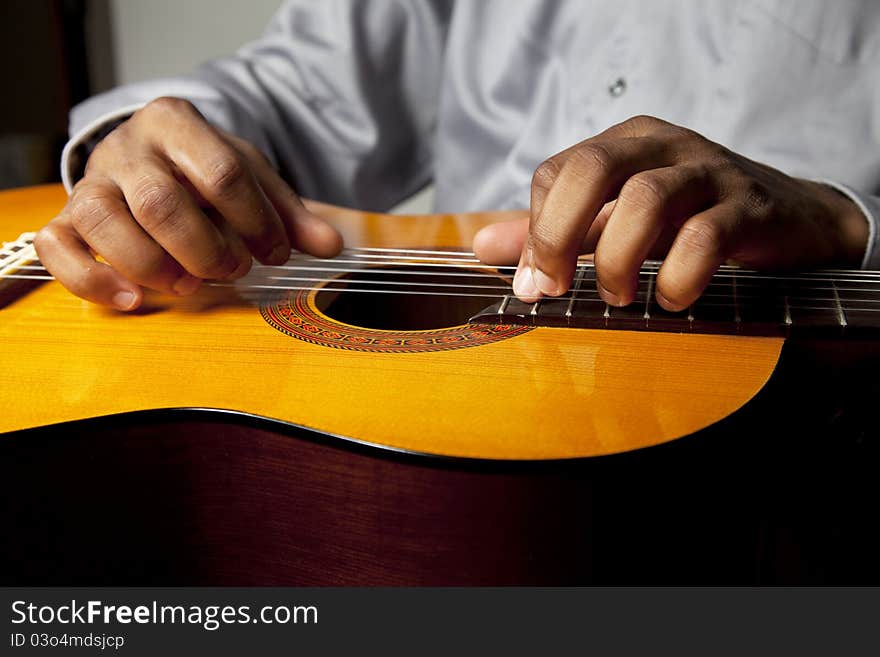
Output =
[{"x1": 515, "y1": 138, "x2": 669, "y2": 300}]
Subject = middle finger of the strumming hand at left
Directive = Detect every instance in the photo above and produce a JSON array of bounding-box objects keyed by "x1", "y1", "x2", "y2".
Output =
[{"x1": 116, "y1": 158, "x2": 244, "y2": 279}]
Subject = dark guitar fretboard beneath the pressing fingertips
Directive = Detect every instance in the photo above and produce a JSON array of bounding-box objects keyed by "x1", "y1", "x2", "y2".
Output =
[{"x1": 470, "y1": 262, "x2": 880, "y2": 336}]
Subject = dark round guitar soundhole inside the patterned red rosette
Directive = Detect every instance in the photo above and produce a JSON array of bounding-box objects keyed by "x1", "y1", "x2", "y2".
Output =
[{"x1": 315, "y1": 266, "x2": 509, "y2": 331}]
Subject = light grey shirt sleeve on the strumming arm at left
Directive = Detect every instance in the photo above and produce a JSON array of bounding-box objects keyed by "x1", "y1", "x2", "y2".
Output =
[{"x1": 61, "y1": 0, "x2": 451, "y2": 210}]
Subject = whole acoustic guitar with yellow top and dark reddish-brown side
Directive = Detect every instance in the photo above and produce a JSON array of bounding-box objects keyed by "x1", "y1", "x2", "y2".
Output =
[{"x1": 0, "y1": 186, "x2": 880, "y2": 584}]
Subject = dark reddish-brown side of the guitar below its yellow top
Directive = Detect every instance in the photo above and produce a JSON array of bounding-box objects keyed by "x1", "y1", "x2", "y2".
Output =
[{"x1": 0, "y1": 342, "x2": 880, "y2": 586}]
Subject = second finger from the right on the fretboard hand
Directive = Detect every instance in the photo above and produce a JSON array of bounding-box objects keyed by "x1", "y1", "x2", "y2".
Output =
[{"x1": 595, "y1": 166, "x2": 714, "y2": 306}]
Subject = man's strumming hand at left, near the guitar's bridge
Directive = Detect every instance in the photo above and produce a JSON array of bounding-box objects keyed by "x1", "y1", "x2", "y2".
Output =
[{"x1": 34, "y1": 98, "x2": 342, "y2": 310}]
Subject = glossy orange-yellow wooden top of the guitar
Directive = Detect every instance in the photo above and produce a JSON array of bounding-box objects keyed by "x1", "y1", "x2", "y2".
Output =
[{"x1": 0, "y1": 186, "x2": 783, "y2": 459}]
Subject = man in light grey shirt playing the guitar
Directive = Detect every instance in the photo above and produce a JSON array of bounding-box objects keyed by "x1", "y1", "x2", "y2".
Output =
[{"x1": 35, "y1": 0, "x2": 880, "y2": 310}]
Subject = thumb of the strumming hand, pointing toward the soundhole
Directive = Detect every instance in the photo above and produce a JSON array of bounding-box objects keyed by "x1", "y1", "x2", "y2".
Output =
[{"x1": 236, "y1": 140, "x2": 342, "y2": 258}]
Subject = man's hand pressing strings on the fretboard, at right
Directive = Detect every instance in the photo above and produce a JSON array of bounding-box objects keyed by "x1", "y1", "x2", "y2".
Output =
[{"x1": 474, "y1": 116, "x2": 868, "y2": 311}]
